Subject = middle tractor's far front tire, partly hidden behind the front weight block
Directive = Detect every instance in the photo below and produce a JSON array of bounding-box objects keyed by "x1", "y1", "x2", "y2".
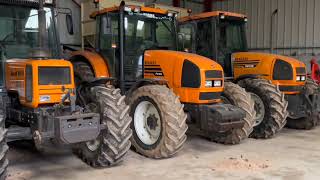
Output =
[{"x1": 218, "y1": 82, "x2": 256, "y2": 144}]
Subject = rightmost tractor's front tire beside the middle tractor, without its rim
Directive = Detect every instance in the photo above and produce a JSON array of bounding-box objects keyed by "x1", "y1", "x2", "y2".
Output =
[{"x1": 239, "y1": 79, "x2": 288, "y2": 139}]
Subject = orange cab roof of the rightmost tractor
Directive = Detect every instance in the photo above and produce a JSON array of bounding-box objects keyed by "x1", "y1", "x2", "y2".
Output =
[{"x1": 179, "y1": 11, "x2": 247, "y2": 22}]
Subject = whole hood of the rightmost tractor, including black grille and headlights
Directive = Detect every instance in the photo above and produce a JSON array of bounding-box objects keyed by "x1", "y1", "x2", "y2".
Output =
[{"x1": 232, "y1": 52, "x2": 306, "y2": 92}]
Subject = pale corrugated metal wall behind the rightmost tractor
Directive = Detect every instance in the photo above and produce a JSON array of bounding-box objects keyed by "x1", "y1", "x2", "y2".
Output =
[{"x1": 213, "y1": 0, "x2": 320, "y2": 63}]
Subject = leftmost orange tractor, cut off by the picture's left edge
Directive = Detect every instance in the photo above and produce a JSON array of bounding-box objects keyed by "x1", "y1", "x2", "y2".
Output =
[{"x1": 0, "y1": 0, "x2": 132, "y2": 179}]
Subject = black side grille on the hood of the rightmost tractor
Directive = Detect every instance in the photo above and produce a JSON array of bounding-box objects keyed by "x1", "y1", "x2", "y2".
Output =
[{"x1": 273, "y1": 59, "x2": 293, "y2": 80}]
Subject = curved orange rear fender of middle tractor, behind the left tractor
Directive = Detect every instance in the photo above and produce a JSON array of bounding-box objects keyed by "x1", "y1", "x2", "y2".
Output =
[{"x1": 71, "y1": 51, "x2": 110, "y2": 77}]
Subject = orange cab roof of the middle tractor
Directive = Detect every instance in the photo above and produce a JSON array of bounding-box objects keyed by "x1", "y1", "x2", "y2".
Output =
[{"x1": 90, "y1": 5, "x2": 168, "y2": 18}]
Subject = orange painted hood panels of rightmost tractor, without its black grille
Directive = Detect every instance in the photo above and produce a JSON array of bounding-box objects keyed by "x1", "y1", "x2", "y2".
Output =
[{"x1": 233, "y1": 52, "x2": 306, "y2": 94}]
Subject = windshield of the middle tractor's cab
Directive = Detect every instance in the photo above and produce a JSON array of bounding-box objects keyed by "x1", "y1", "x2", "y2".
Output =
[{"x1": 124, "y1": 13, "x2": 176, "y2": 53}]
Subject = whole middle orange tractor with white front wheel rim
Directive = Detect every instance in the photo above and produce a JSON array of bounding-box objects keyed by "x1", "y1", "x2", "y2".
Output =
[{"x1": 70, "y1": 1, "x2": 254, "y2": 158}]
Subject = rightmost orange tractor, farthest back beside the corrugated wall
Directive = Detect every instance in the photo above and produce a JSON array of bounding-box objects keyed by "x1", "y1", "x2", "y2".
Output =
[{"x1": 179, "y1": 11, "x2": 319, "y2": 138}]
